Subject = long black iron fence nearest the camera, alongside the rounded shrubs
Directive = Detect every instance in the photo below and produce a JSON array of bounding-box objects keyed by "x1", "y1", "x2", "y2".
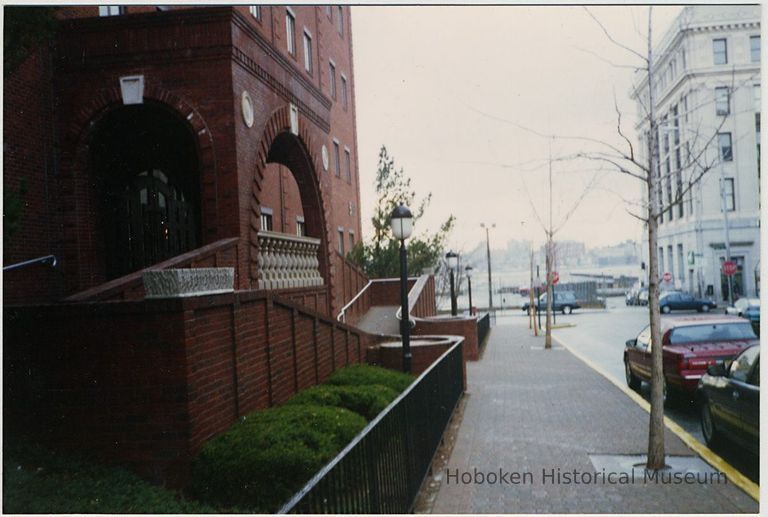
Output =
[{"x1": 279, "y1": 339, "x2": 464, "y2": 513}]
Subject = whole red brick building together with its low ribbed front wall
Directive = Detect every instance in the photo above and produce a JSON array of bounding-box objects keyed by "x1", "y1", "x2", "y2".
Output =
[{"x1": 3, "y1": 5, "x2": 388, "y2": 486}]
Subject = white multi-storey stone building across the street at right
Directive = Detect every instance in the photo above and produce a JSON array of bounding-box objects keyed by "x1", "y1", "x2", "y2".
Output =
[{"x1": 631, "y1": 5, "x2": 761, "y2": 301}]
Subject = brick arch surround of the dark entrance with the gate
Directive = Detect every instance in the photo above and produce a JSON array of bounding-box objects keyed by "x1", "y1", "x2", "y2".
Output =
[{"x1": 59, "y1": 80, "x2": 216, "y2": 293}]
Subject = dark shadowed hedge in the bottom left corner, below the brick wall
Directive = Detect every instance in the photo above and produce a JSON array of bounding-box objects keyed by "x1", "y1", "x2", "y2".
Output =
[{"x1": 3, "y1": 440, "x2": 217, "y2": 514}]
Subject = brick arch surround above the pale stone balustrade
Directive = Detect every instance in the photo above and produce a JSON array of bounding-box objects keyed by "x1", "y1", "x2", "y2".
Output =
[{"x1": 249, "y1": 105, "x2": 333, "y2": 307}]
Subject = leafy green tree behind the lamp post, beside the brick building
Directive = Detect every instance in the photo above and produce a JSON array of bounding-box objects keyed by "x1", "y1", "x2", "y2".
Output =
[{"x1": 349, "y1": 146, "x2": 455, "y2": 278}]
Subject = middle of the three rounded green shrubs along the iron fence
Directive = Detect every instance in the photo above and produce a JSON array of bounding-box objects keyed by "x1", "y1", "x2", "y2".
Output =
[{"x1": 288, "y1": 384, "x2": 398, "y2": 421}]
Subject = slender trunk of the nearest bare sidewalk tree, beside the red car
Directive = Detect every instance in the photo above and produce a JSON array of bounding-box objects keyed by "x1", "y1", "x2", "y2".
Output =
[{"x1": 646, "y1": 7, "x2": 665, "y2": 470}]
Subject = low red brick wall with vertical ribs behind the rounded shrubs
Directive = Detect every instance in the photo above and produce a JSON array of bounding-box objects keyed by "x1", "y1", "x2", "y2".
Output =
[{"x1": 3, "y1": 292, "x2": 370, "y2": 486}]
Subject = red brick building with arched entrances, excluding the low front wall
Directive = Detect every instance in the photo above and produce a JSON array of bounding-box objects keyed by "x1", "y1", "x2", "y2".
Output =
[{"x1": 3, "y1": 5, "x2": 361, "y2": 314}]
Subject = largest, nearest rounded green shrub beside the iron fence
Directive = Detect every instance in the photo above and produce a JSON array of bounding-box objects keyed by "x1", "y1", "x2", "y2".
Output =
[{"x1": 188, "y1": 404, "x2": 366, "y2": 513}]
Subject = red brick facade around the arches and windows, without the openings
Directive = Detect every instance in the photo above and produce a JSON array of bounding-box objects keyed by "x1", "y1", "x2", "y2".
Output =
[{"x1": 4, "y1": 6, "x2": 360, "y2": 309}]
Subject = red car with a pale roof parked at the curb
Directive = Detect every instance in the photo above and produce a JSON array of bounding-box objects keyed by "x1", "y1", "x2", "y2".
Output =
[{"x1": 624, "y1": 316, "x2": 760, "y2": 395}]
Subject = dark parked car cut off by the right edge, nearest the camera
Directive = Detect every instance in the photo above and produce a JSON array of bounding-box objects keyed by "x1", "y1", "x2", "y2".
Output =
[{"x1": 696, "y1": 345, "x2": 760, "y2": 454}]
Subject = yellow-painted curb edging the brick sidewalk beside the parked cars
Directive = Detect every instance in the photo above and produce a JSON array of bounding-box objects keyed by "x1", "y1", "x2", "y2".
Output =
[{"x1": 552, "y1": 335, "x2": 760, "y2": 503}]
